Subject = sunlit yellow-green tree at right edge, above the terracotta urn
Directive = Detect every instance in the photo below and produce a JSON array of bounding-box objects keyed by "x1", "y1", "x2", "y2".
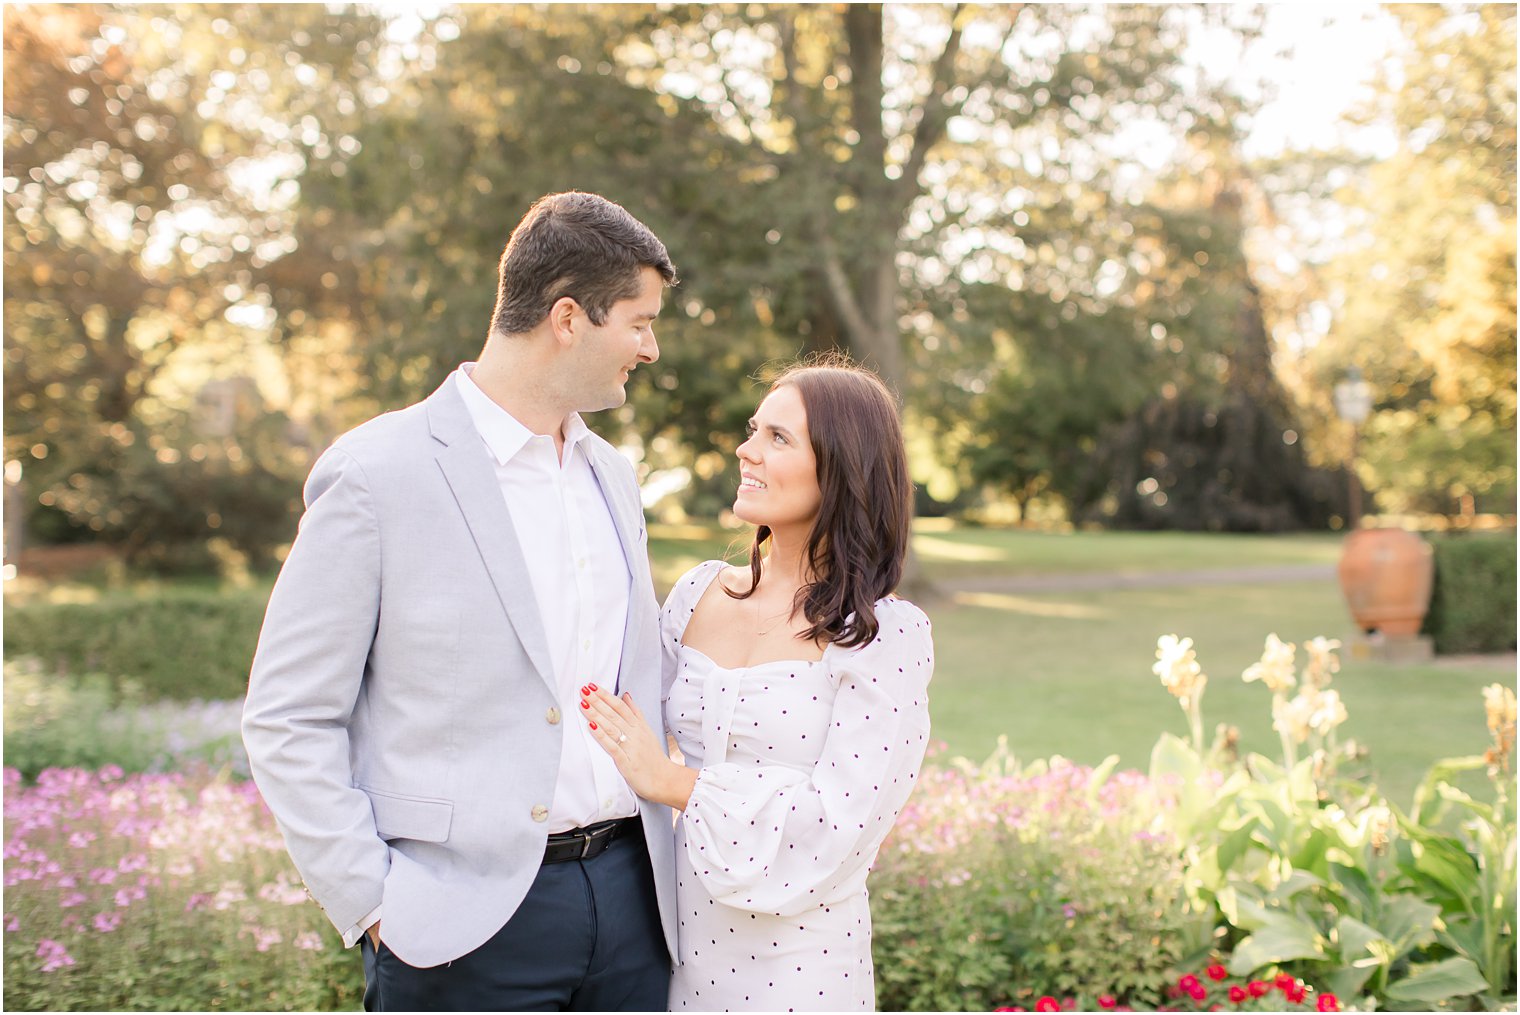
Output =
[{"x1": 1313, "y1": 5, "x2": 1515, "y2": 512}]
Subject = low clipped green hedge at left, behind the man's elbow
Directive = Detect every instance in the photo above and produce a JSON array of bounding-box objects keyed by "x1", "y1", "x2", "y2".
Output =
[{"x1": 5, "y1": 588, "x2": 269, "y2": 700}]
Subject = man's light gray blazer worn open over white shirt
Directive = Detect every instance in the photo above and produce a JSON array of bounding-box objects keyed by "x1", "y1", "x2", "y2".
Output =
[{"x1": 243, "y1": 377, "x2": 676, "y2": 966}]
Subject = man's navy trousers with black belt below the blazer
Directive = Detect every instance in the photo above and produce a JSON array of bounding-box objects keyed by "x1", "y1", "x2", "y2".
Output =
[{"x1": 360, "y1": 831, "x2": 670, "y2": 1012}]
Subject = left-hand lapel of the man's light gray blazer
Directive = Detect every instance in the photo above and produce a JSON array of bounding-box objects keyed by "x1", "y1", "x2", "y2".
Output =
[{"x1": 427, "y1": 375, "x2": 559, "y2": 696}]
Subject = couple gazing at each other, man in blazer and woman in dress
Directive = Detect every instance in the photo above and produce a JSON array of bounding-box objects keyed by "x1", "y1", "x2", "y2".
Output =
[{"x1": 243, "y1": 193, "x2": 933, "y2": 1010}]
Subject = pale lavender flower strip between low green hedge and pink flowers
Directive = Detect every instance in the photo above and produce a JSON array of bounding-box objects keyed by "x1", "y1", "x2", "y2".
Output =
[{"x1": 5, "y1": 658, "x2": 248, "y2": 779}]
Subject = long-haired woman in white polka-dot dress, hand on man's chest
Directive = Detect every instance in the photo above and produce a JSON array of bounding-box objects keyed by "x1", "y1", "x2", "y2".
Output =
[{"x1": 582, "y1": 363, "x2": 933, "y2": 1012}]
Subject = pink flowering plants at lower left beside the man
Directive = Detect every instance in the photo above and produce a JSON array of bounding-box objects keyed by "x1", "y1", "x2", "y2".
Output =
[{"x1": 5, "y1": 767, "x2": 363, "y2": 1010}]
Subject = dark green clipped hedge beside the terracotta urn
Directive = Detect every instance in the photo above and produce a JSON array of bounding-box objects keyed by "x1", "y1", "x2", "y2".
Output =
[{"x1": 1423, "y1": 532, "x2": 1515, "y2": 655}]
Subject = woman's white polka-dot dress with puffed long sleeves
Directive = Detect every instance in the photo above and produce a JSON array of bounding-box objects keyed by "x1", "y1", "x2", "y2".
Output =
[{"x1": 660, "y1": 561, "x2": 933, "y2": 1012}]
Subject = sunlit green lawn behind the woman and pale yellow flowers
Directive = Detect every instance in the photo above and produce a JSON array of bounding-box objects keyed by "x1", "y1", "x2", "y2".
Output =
[{"x1": 649, "y1": 520, "x2": 1514, "y2": 802}]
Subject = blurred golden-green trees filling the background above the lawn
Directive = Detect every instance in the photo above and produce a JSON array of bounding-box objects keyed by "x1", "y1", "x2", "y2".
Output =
[{"x1": 5, "y1": 5, "x2": 1515, "y2": 567}]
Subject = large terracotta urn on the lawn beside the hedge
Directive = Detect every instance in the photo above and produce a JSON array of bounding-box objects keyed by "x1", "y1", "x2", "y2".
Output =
[{"x1": 1339, "y1": 529, "x2": 1435, "y2": 638}]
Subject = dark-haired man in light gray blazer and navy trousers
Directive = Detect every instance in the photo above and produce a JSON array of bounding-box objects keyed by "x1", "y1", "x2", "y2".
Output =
[{"x1": 243, "y1": 193, "x2": 676, "y2": 1010}]
